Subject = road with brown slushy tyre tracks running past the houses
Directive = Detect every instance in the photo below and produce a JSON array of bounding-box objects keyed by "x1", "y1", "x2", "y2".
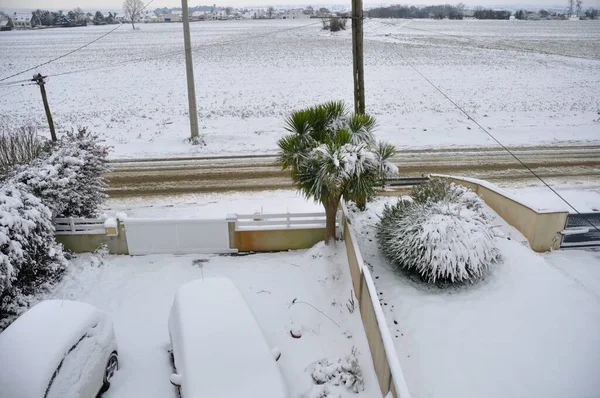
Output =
[{"x1": 108, "y1": 145, "x2": 600, "y2": 197}]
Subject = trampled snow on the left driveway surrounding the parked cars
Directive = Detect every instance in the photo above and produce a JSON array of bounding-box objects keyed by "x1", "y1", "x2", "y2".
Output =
[{"x1": 53, "y1": 244, "x2": 381, "y2": 398}]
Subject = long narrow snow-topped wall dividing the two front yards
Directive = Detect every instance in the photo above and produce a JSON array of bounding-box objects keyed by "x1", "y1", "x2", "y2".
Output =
[{"x1": 342, "y1": 205, "x2": 410, "y2": 398}]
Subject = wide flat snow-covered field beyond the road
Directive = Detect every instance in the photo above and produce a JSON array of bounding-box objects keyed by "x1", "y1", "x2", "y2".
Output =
[{"x1": 0, "y1": 20, "x2": 600, "y2": 158}]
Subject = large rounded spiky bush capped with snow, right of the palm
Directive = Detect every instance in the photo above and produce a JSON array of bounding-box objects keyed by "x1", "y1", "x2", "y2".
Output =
[{"x1": 377, "y1": 196, "x2": 501, "y2": 283}]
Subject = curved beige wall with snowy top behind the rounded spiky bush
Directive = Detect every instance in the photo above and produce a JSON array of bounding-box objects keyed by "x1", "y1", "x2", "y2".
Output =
[{"x1": 436, "y1": 175, "x2": 569, "y2": 252}]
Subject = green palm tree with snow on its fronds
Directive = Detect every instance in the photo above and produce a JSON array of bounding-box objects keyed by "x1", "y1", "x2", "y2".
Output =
[{"x1": 278, "y1": 102, "x2": 398, "y2": 242}]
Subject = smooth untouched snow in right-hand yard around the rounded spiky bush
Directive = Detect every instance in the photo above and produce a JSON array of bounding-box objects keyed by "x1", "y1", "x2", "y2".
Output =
[{"x1": 352, "y1": 198, "x2": 600, "y2": 398}]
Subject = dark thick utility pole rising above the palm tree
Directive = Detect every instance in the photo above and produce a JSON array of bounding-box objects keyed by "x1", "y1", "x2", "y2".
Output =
[{"x1": 352, "y1": 0, "x2": 365, "y2": 114}]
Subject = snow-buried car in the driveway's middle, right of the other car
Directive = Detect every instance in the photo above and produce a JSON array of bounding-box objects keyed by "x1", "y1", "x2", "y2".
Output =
[{"x1": 169, "y1": 278, "x2": 288, "y2": 398}]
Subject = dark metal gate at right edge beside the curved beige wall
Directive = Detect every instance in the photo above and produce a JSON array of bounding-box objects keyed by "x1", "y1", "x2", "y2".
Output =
[{"x1": 560, "y1": 212, "x2": 600, "y2": 248}]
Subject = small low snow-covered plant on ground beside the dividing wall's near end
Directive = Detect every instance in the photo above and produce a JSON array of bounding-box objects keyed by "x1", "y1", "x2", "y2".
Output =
[{"x1": 311, "y1": 348, "x2": 365, "y2": 393}]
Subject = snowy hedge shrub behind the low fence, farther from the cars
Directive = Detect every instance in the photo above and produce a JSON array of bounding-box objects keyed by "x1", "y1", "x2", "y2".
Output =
[{"x1": 13, "y1": 128, "x2": 108, "y2": 217}]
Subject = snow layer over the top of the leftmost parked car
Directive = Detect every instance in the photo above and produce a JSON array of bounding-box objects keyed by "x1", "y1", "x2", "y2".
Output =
[{"x1": 0, "y1": 300, "x2": 100, "y2": 398}]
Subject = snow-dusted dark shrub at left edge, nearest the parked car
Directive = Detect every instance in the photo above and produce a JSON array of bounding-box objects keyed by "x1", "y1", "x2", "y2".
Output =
[{"x1": 0, "y1": 182, "x2": 67, "y2": 330}]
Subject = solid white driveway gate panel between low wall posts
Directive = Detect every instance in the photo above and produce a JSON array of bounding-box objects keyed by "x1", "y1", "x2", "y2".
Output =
[{"x1": 124, "y1": 218, "x2": 237, "y2": 255}]
